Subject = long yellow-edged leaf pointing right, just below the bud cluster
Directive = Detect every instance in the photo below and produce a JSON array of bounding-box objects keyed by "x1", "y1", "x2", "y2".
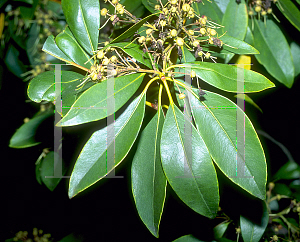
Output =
[{"x1": 176, "y1": 61, "x2": 275, "y2": 93}]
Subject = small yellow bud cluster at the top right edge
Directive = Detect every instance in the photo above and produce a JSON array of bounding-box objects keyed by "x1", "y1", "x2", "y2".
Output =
[{"x1": 248, "y1": 0, "x2": 278, "y2": 17}]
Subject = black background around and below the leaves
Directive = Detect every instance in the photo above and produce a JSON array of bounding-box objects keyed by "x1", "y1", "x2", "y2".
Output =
[{"x1": 0, "y1": 5, "x2": 300, "y2": 241}]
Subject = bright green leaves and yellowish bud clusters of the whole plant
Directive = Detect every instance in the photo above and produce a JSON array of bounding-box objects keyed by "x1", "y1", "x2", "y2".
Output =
[{"x1": 5, "y1": 0, "x2": 300, "y2": 241}]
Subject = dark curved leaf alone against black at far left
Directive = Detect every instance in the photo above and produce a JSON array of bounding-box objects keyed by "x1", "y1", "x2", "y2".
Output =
[{"x1": 9, "y1": 109, "x2": 53, "y2": 148}]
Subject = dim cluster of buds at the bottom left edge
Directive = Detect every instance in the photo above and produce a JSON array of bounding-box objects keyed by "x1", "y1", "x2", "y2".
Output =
[{"x1": 13, "y1": 228, "x2": 52, "y2": 242}]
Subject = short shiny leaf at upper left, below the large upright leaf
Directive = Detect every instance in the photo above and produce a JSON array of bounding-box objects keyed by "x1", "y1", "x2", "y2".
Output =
[{"x1": 55, "y1": 27, "x2": 93, "y2": 69}]
